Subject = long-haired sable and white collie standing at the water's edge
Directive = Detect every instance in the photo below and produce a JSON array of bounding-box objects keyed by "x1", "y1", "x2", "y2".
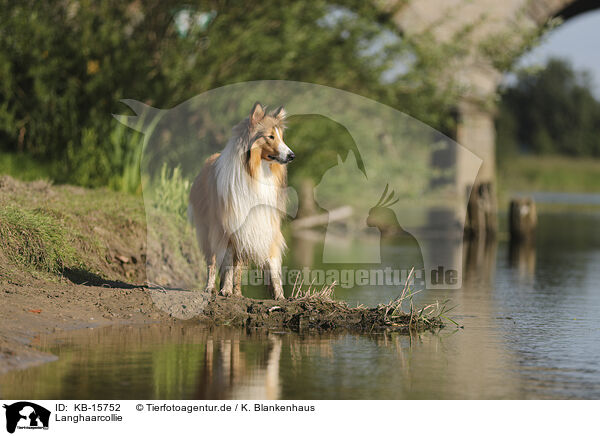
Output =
[{"x1": 189, "y1": 102, "x2": 295, "y2": 299}]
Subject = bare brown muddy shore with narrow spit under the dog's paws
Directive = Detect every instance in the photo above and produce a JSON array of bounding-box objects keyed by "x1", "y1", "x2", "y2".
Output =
[{"x1": 0, "y1": 282, "x2": 442, "y2": 373}]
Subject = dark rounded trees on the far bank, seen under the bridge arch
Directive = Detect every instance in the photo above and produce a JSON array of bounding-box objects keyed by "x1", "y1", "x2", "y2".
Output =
[{"x1": 497, "y1": 59, "x2": 600, "y2": 161}]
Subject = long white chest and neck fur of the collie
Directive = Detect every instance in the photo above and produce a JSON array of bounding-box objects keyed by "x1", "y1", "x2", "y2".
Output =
[{"x1": 216, "y1": 144, "x2": 280, "y2": 265}]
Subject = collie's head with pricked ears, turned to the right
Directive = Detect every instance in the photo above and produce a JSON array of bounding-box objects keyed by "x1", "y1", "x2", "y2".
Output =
[{"x1": 241, "y1": 102, "x2": 296, "y2": 165}]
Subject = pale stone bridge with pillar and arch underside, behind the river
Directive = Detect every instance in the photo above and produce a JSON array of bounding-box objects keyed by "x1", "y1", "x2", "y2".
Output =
[{"x1": 380, "y1": 0, "x2": 600, "y2": 233}]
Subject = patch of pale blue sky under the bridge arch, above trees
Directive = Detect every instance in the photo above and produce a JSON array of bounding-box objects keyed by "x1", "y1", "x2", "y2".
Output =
[{"x1": 518, "y1": 10, "x2": 600, "y2": 98}]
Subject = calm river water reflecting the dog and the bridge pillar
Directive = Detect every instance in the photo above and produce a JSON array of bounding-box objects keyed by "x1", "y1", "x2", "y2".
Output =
[{"x1": 0, "y1": 201, "x2": 600, "y2": 399}]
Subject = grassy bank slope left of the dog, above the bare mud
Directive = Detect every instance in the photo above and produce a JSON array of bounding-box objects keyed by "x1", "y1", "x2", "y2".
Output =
[{"x1": 0, "y1": 175, "x2": 203, "y2": 283}]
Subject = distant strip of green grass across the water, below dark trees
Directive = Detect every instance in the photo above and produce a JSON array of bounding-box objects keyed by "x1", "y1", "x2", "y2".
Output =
[{"x1": 498, "y1": 156, "x2": 600, "y2": 193}]
